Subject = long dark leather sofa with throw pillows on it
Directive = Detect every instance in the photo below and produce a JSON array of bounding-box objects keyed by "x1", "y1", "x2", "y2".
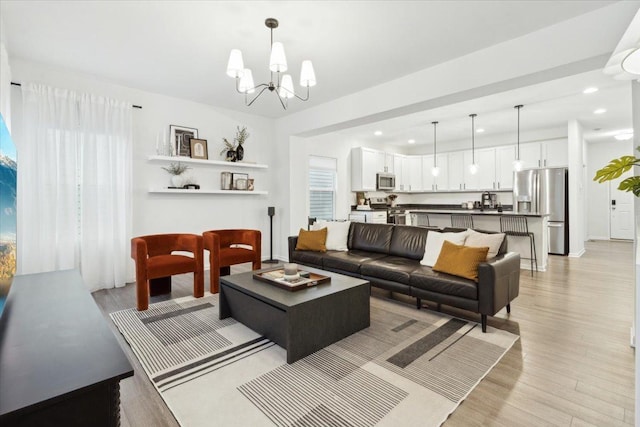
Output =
[{"x1": 289, "y1": 222, "x2": 520, "y2": 332}]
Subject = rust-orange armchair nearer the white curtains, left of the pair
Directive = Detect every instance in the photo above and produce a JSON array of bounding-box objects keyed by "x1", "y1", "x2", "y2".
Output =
[{"x1": 131, "y1": 234, "x2": 204, "y2": 311}]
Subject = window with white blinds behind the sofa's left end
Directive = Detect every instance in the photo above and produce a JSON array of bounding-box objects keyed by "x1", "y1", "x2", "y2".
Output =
[{"x1": 309, "y1": 156, "x2": 337, "y2": 220}]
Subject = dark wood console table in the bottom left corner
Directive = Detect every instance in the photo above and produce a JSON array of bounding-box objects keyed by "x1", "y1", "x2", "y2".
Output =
[{"x1": 0, "y1": 270, "x2": 133, "y2": 426}]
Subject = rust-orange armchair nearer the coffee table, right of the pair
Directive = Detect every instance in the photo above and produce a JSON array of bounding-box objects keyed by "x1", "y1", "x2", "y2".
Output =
[{"x1": 202, "y1": 229, "x2": 262, "y2": 294}]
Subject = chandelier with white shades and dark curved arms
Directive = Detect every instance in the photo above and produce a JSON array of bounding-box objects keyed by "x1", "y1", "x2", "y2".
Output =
[{"x1": 227, "y1": 18, "x2": 316, "y2": 110}]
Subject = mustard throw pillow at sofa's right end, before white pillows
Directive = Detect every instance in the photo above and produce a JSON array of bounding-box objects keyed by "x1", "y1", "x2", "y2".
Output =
[{"x1": 433, "y1": 240, "x2": 489, "y2": 282}]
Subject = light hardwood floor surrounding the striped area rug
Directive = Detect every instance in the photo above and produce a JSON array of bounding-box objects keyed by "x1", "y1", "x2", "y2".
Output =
[{"x1": 93, "y1": 241, "x2": 634, "y2": 427}]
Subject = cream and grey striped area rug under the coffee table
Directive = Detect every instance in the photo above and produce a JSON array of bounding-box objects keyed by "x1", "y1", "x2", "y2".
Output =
[{"x1": 111, "y1": 294, "x2": 518, "y2": 427}]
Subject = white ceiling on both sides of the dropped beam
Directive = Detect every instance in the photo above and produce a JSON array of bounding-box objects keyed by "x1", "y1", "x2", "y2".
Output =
[{"x1": 0, "y1": 0, "x2": 631, "y2": 145}]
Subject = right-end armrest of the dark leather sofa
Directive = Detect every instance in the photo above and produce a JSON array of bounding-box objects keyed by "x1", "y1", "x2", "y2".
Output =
[{"x1": 478, "y1": 252, "x2": 520, "y2": 316}]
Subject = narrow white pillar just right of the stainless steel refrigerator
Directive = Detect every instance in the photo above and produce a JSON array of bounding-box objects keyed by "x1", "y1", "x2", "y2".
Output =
[{"x1": 567, "y1": 120, "x2": 585, "y2": 257}]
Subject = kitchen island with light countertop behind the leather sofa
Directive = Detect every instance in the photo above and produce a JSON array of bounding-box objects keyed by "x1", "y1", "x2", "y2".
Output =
[{"x1": 406, "y1": 208, "x2": 549, "y2": 271}]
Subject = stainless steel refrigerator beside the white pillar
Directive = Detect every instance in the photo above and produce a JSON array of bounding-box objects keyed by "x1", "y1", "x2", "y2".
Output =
[{"x1": 513, "y1": 168, "x2": 569, "y2": 255}]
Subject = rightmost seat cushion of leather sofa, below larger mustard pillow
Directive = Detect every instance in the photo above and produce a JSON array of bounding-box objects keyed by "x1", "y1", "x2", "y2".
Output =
[{"x1": 409, "y1": 266, "x2": 478, "y2": 300}]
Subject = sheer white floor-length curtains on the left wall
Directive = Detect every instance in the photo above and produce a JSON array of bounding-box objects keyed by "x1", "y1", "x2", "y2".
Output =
[{"x1": 17, "y1": 83, "x2": 132, "y2": 291}]
